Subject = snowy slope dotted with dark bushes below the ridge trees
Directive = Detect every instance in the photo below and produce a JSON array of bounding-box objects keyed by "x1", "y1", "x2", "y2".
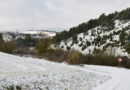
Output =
[{"x1": 59, "y1": 20, "x2": 130, "y2": 56}]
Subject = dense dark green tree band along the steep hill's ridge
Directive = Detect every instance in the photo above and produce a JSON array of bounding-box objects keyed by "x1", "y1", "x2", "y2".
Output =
[{"x1": 54, "y1": 8, "x2": 130, "y2": 43}]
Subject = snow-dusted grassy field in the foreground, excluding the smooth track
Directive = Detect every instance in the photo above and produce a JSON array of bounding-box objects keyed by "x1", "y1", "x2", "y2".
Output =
[{"x1": 0, "y1": 53, "x2": 111, "y2": 90}]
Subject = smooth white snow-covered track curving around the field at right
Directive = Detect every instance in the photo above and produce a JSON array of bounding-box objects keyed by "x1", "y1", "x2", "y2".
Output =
[{"x1": 85, "y1": 65, "x2": 130, "y2": 90}]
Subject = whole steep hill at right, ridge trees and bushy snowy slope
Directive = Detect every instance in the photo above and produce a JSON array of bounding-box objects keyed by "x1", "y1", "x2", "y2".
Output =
[{"x1": 54, "y1": 8, "x2": 130, "y2": 57}]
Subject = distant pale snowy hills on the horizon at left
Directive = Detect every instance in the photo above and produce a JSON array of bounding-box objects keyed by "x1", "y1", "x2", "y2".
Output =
[{"x1": 0, "y1": 30, "x2": 56, "y2": 42}]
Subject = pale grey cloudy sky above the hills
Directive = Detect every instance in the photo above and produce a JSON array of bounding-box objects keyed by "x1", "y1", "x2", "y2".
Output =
[{"x1": 0, "y1": 0, "x2": 130, "y2": 31}]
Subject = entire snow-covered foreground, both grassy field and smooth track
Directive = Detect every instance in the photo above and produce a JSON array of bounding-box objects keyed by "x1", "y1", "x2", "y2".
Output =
[{"x1": 0, "y1": 53, "x2": 130, "y2": 90}]
